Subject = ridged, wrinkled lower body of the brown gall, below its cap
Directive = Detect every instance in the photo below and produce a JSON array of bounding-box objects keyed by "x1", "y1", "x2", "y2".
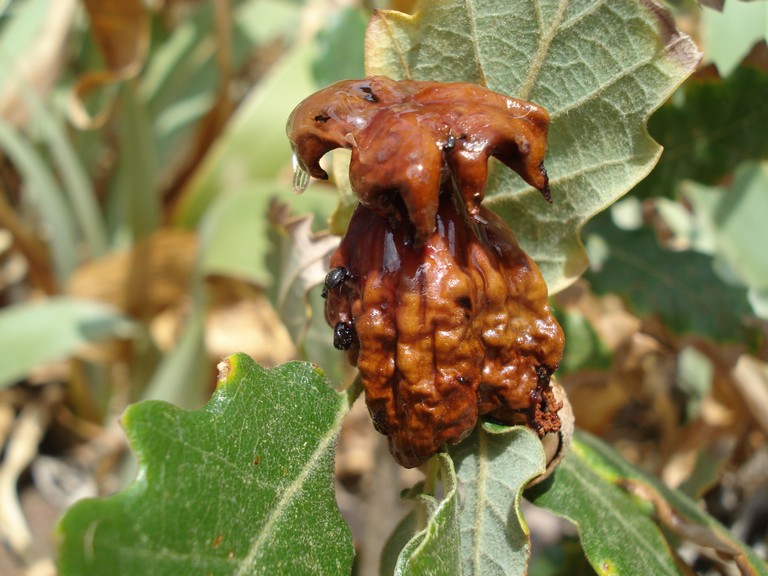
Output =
[{"x1": 326, "y1": 191, "x2": 563, "y2": 467}]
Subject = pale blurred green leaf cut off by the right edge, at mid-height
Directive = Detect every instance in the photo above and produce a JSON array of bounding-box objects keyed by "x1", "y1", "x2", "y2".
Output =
[{"x1": 684, "y1": 162, "x2": 768, "y2": 320}]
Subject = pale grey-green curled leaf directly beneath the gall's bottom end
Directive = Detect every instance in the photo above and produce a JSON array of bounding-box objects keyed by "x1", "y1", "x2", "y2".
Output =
[{"x1": 381, "y1": 425, "x2": 545, "y2": 576}]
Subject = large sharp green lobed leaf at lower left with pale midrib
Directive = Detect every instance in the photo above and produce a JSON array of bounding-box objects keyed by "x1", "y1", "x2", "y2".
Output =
[{"x1": 59, "y1": 354, "x2": 353, "y2": 576}]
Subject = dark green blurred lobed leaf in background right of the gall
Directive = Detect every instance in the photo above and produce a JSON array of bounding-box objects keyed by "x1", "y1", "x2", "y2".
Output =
[{"x1": 585, "y1": 213, "x2": 750, "y2": 341}]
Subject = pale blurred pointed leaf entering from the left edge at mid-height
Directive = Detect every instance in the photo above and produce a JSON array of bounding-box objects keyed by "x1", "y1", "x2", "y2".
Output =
[{"x1": 0, "y1": 296, "x2": 136, "y2": 388}]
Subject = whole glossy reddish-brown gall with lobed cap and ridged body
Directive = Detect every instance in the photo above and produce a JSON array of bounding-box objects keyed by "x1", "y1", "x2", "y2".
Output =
[{"x1": 288, "y1": 77, "x2": 563, "y2": 467}]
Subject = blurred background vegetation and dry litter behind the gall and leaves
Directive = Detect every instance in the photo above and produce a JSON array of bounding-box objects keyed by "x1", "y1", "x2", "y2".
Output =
[{"x1": 0, "y1": 0, "x2": 768, "y2": 574}]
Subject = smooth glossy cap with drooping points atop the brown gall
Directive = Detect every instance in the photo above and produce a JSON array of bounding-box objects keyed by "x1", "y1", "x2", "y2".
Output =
[{"x1": 288, "y1": 76, "x2": 550, "y2": 243}]
